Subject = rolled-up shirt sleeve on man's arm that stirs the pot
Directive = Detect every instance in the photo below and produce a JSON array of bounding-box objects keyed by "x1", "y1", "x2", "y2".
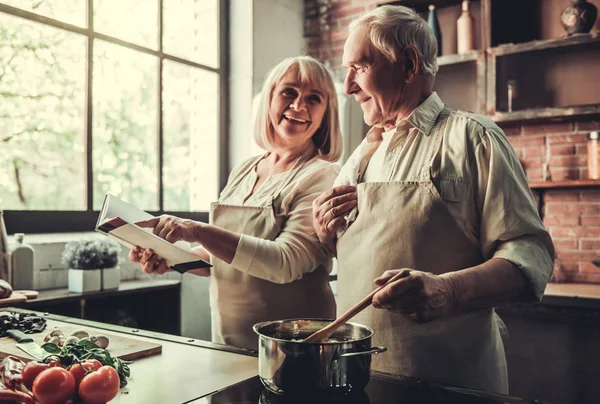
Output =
[{"x1": 475, "y1": 127, "x2": 555, "y2": 300}]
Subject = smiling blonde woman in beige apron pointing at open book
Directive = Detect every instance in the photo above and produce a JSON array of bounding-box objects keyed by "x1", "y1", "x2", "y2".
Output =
[{"x1": 130, "y1": 56, "x2": 342, "y2": 349}]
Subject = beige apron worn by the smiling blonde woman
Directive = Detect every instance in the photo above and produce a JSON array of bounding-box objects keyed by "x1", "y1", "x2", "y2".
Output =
[{"x1": 210, "y1": 156, "x2": 335, "y2": 349}]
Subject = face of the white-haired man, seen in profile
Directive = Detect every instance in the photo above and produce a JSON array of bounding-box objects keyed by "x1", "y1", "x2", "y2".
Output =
[{"x1": 342, "y1": 27, "x2": 405, "y2": 127}]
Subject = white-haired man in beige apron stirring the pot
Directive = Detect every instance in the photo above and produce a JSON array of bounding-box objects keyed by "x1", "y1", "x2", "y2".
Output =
[{"x1": 313, "y1": 6, "x2": 554, "y2": 393}]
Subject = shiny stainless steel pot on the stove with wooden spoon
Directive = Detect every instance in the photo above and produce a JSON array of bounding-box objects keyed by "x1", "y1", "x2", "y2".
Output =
[{"x1": 253, "y1": 319, "x2": 386, "y2": 395}]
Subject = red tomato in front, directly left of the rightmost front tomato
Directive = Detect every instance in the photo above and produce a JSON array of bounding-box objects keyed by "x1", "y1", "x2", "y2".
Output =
[{"x1": 32, "y1": 367, "x2": 75, "y2": 404}]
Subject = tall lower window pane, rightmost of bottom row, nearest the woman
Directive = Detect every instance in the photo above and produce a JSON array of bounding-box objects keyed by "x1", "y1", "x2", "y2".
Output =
[{"x1": 163, "y1": 60, "x2": 219, "y2": 211}]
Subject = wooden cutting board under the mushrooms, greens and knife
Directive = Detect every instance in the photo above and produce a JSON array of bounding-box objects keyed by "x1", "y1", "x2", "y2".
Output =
[{"x1": 0, "y1": 320, "x2": 162, "y2": 362}]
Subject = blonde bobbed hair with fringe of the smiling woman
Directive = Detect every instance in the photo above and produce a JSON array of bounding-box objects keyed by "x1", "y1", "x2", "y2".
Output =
[{"x1": 254, "y1": 56, "x2": 342, "y2": 162}]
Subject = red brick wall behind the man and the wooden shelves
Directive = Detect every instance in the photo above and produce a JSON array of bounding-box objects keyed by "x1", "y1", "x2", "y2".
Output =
[{"x1": 305, "y1": 0, "x2": 600, "y2": 283}]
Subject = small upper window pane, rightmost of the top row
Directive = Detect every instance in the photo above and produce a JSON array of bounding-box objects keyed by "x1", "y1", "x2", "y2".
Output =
[{"x1": 163, "y1": 0, "x2": 219, "y2": 67}]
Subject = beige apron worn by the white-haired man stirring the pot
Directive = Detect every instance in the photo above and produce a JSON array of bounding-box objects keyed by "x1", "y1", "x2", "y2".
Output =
[{"x1": 337, "y1": 109, "x2": 508, "y2": 393}]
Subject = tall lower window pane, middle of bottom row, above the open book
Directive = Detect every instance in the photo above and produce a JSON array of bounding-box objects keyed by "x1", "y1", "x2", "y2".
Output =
[{"x1": 92, "y1": 40, "x2": 158, "y2": 210}]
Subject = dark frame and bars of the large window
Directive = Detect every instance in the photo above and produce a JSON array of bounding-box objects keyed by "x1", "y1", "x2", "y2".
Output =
[{"x1": 0, "y1": 0, "x2": 230, "y2": 234}]
